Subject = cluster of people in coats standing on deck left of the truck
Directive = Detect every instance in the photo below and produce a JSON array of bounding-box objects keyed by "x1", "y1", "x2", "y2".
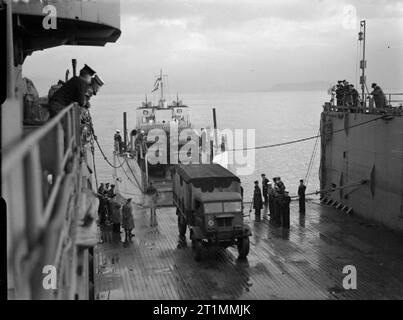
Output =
[{"x1": 98, "y1": 183, "x2": 135, "y2": 242}]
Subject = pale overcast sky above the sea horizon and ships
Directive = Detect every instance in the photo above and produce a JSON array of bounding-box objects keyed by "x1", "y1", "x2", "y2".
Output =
[{"x1": 23, "y1": 0, "x2": 403, "y2": 94}]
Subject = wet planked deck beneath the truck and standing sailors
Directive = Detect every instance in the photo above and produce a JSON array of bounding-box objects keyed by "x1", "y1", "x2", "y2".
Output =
[{"x1": 94, "y1": 203, "x2": 403, "y2": 300}]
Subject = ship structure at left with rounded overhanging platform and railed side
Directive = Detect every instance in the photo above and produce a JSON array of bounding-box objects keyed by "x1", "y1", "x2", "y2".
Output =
[{"x1": 0, "y1": 0, "x2": 120, "y2": 299}]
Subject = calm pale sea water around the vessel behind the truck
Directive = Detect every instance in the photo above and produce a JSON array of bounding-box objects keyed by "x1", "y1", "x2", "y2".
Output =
[{"x1": 91, "y1": 91, "x2": 329, "y2": 199}]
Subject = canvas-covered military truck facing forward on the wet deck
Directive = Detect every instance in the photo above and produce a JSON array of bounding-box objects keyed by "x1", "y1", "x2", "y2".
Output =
[{"x1": 173, "y1": 164, "x2": 251, "y2": 261}]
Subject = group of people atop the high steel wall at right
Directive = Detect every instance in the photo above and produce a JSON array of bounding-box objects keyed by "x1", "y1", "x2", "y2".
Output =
[{"x1": 330, "y1": 80, "x2": 387, "y2": 111}]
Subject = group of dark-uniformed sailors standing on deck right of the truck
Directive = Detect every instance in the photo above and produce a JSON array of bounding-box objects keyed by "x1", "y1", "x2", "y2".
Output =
[{"x1": 249, "y1": 173, "x2": 306, "y2": 228}]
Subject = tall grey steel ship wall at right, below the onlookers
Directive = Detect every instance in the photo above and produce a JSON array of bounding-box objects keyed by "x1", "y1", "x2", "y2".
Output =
[{"x1": 320, "y1": 111, "x2": 403, "y2": 230}]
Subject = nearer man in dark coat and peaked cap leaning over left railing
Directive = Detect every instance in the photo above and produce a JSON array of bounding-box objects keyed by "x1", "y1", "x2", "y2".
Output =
[{"x1": 49, "y1": 65, "x2": 95, "y2": 117}]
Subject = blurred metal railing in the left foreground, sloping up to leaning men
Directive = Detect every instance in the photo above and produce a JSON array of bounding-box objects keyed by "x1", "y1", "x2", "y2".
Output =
[{"x1": 1, "y1": 105, "x2": 81, "y2": 298}]
